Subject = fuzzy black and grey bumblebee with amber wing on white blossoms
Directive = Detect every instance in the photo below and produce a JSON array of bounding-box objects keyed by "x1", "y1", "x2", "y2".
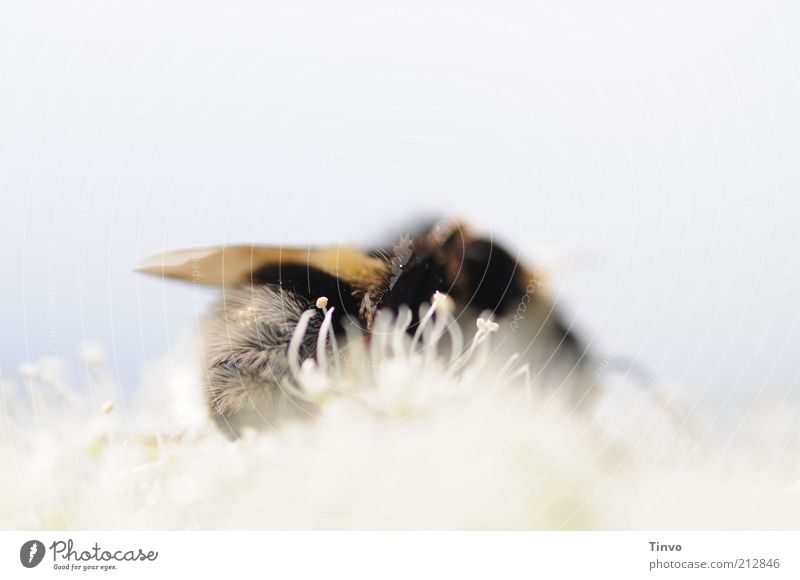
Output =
[{"x1": 140, "y1": 222, "x2": 586, "y2": 435}]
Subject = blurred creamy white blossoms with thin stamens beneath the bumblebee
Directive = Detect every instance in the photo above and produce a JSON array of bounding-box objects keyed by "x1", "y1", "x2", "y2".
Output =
[{"x1": 0, "y1": 301, "x2": 800, "y2": 529}]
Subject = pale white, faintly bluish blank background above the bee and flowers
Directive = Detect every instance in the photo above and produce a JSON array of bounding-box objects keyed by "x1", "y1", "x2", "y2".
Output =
[{"x1": 0, "y1": 1, "x2": 800, "y2": 406}]
